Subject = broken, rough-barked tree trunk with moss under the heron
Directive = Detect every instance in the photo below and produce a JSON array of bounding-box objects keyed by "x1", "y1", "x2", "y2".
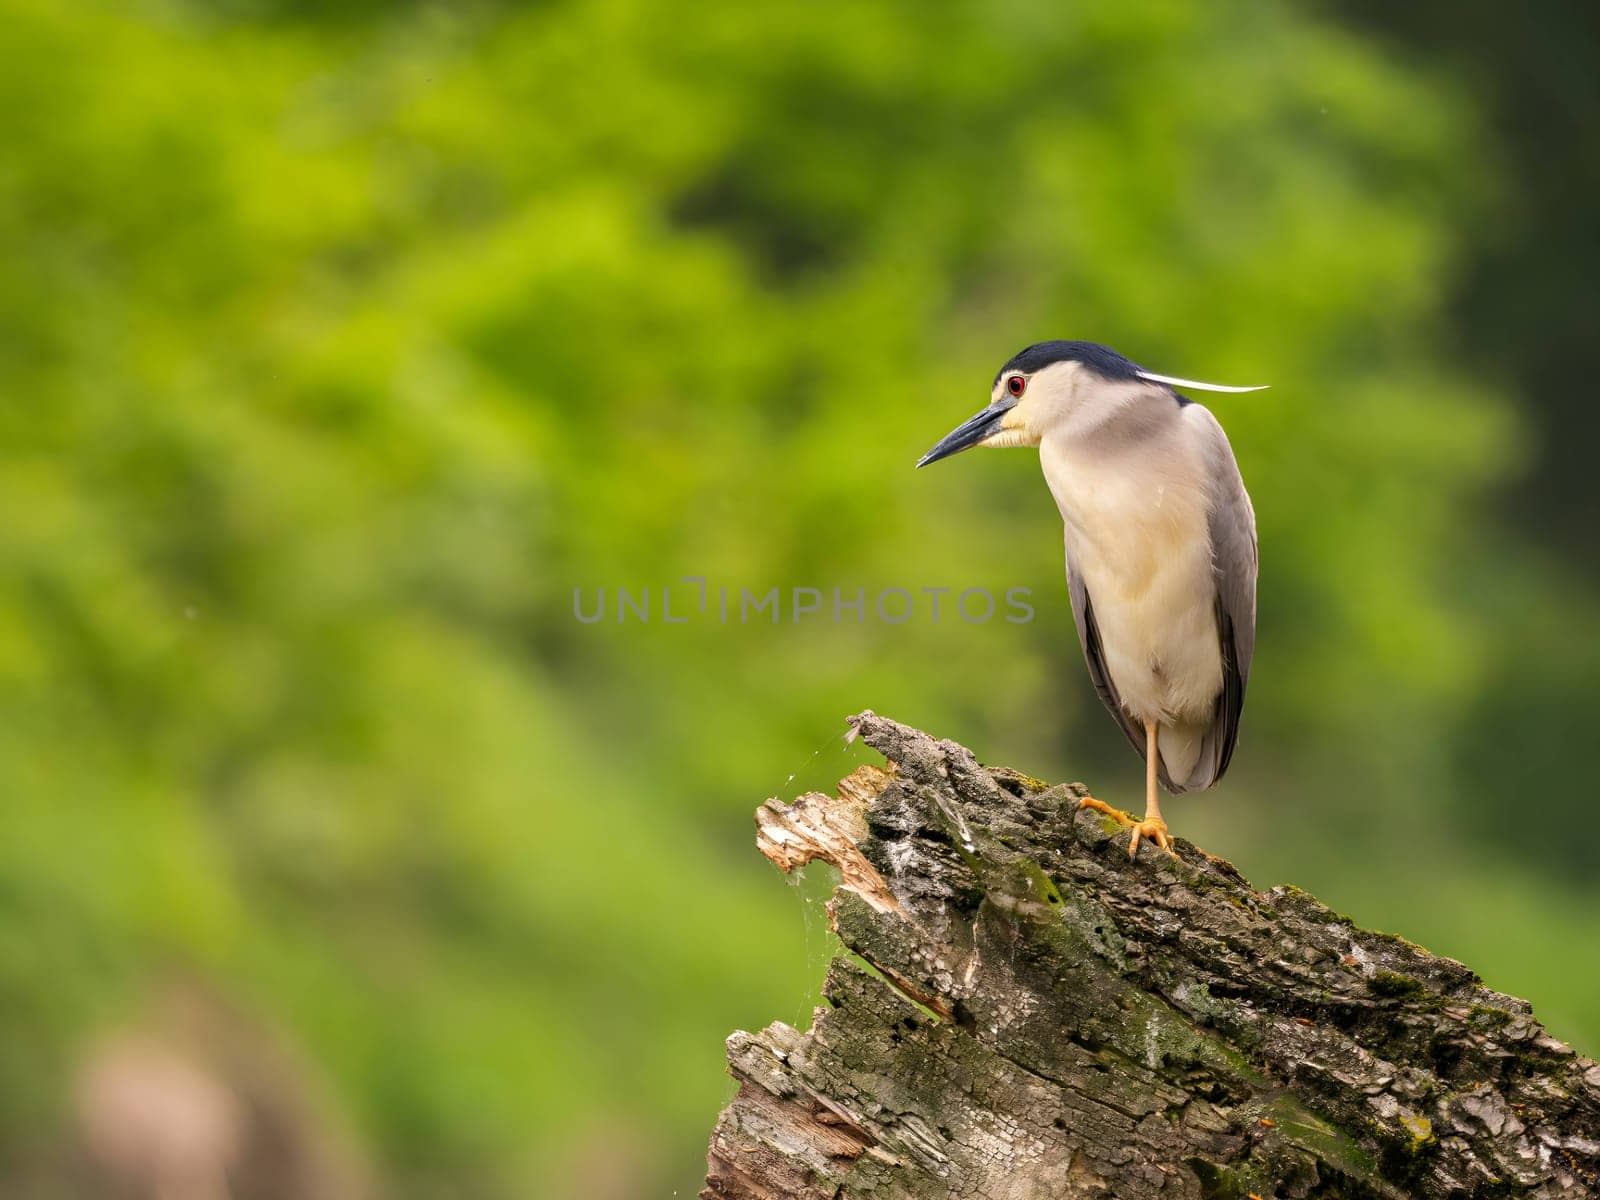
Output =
[{"x1": 702, "y1": 714, "x2": 1600, "y2": 1200}]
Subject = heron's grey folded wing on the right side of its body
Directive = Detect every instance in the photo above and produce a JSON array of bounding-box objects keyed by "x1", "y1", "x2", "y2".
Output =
[{"x1": 1190, "y1": 413, "x2": 1258, "y2": 787}]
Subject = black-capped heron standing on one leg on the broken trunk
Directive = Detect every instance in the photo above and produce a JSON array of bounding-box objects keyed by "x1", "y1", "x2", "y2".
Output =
[{"x1": 917, "y1": 341, "x2": 1262, "y2": 858}]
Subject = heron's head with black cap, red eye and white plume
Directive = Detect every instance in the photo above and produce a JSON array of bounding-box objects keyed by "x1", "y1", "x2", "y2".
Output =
[{"x1": 917, "y1": 341, "x2": 1261, "y2": 467}]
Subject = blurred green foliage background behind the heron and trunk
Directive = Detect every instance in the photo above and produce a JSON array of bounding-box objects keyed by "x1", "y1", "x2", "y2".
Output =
[{"x1": 0, "y1": 0, "x2": 1600, "y2": 1200}]
